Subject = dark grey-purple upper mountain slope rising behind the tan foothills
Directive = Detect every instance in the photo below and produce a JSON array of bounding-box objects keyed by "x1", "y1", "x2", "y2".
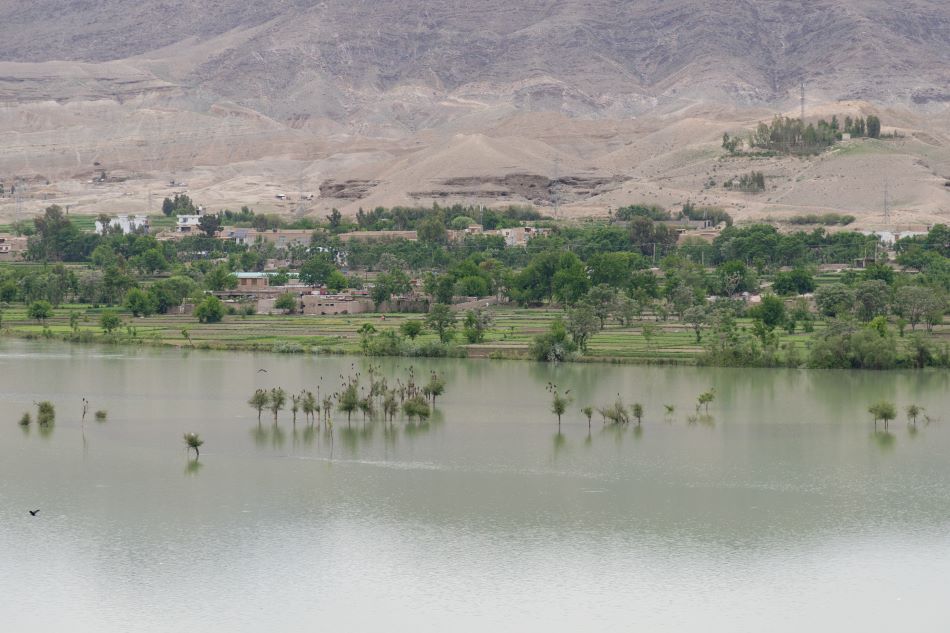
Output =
[{"x1": 0, "y1": 0, "x2": 950, "y2": 119}]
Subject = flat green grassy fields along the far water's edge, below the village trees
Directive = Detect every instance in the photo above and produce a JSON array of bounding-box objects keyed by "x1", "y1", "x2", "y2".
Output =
[{"x1": 2, "y1": 305, "x2": 950, "y2": 364}]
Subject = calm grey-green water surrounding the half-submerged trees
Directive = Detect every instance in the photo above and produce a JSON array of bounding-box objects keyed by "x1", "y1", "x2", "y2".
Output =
[{"x1": 0, "y1": 340, "x2": 950, "y2": 633}]
